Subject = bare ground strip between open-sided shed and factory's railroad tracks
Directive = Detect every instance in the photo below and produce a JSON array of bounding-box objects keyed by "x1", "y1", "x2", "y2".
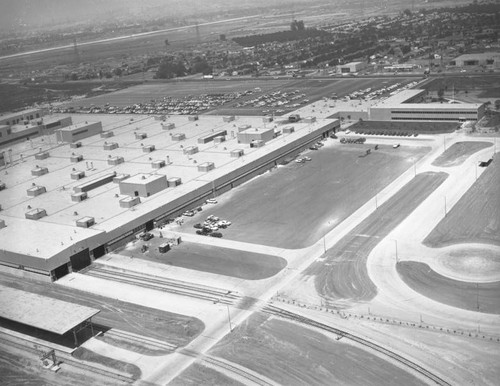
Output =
[{"x1": 0, "y1": 274, "x2": 205, "y2": 346}]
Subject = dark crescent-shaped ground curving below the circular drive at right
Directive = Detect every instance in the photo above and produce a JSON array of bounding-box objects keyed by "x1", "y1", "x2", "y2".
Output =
[{"x1": 396, "y1": 261, "x2": 500, "y2": 314}]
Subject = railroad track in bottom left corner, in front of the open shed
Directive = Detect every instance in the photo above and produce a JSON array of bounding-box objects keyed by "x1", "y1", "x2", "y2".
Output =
[{"x1": 0, "y1": 334, "x2": 135, "y2": 383}]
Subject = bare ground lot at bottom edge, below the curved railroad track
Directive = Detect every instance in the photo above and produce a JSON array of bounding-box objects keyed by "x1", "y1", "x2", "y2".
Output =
[{"x1": 210, "y1": 313, "x2": 423, "y2": 386}]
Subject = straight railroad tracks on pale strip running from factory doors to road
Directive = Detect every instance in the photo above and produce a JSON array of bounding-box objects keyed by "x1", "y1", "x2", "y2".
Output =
[{"x1": 84, "y1": 265, "x2": 241, "y2": 305}]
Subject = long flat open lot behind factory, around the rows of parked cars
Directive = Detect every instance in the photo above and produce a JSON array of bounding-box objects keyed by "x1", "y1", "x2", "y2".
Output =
[{"x1": 60, "y1": 77, "x2": 414, "y2": 115}]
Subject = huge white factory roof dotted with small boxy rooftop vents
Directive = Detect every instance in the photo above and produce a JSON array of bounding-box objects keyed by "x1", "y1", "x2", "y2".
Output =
[{"x1": 0, "y1": 114, "x2": 334, "y2": 259}]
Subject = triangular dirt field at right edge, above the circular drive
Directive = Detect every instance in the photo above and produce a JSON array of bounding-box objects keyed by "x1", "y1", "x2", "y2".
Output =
[{"x1": 424, "y1": 159, "x2": 500, "y2": 247}]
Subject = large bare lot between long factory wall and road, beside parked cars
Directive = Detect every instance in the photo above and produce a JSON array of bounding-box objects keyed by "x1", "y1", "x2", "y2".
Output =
[{"x1": 182, "y1": 143, "x2": 428, "y2": 248}]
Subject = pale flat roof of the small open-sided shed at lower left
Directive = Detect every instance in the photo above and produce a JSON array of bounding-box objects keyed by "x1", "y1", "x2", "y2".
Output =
[{"x1": 0, "y1": 286, "x2": 100, "y2": 335}]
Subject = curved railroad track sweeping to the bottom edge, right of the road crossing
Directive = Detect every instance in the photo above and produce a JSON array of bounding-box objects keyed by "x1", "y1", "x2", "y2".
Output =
[{"x1": 263, "y1": 305, "x2": 451, "y2": 386}]
